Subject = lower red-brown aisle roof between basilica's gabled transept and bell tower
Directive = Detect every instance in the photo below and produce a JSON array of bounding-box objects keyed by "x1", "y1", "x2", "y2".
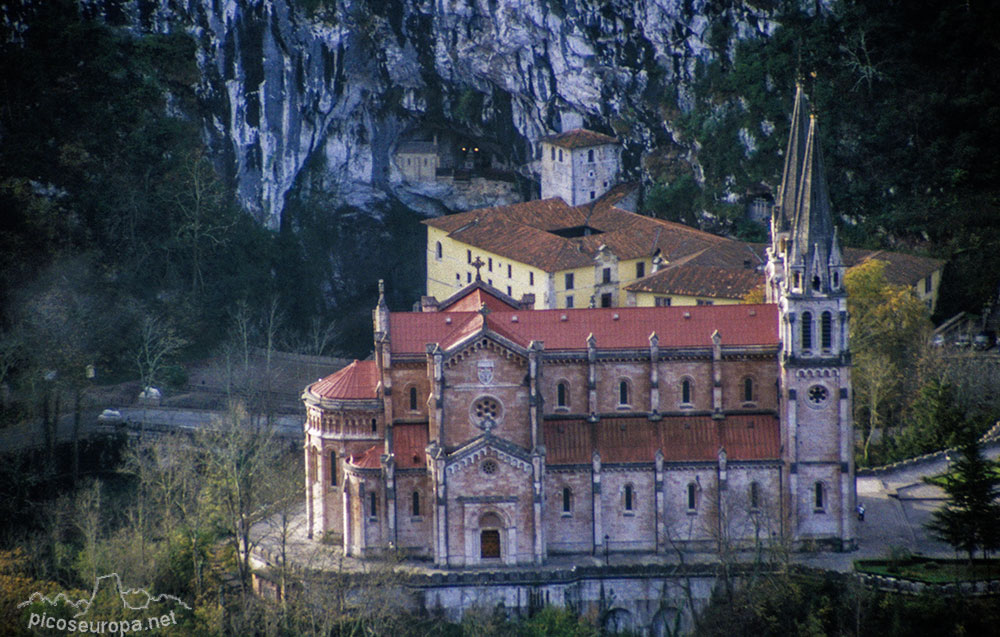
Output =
[{"x1": 543, "y1": 414, "x2": 781, "y2": 464}]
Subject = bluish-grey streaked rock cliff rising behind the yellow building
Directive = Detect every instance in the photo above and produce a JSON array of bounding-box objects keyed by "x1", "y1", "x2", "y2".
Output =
[{"x1": 80, "y1": 0, "x2": 775, "y2": 228}]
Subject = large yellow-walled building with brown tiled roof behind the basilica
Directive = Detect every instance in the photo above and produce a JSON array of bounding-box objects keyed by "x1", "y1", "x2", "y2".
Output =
[{"x1": 424, "y1": 186, "x2": 729, "y2": 309}]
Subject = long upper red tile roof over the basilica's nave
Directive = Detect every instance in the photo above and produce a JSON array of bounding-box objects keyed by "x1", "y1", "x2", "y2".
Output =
[{"x1": 389, "y1": 304, "x2": 778, "y2": 354}]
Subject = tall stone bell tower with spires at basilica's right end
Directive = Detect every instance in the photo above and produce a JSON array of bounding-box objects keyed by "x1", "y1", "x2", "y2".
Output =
[{"x1": 767, "y1": 85, "x2": 856, "y2": 549}]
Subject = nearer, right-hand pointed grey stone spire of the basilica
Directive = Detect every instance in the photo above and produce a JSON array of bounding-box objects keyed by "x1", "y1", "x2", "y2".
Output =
[{"x1": 786, "y1": 114, "x2": 840, "y2": 268}]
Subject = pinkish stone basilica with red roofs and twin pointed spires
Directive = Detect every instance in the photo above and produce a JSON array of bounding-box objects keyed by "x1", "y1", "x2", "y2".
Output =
[{"x1": 303, "y1": 88, "x2": 856, "y2": 567}]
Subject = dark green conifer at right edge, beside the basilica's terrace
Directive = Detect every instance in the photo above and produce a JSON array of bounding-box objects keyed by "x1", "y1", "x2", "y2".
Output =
[{"x1": 927, "y1": 437, "x2": 1000, "y2": 564}]
